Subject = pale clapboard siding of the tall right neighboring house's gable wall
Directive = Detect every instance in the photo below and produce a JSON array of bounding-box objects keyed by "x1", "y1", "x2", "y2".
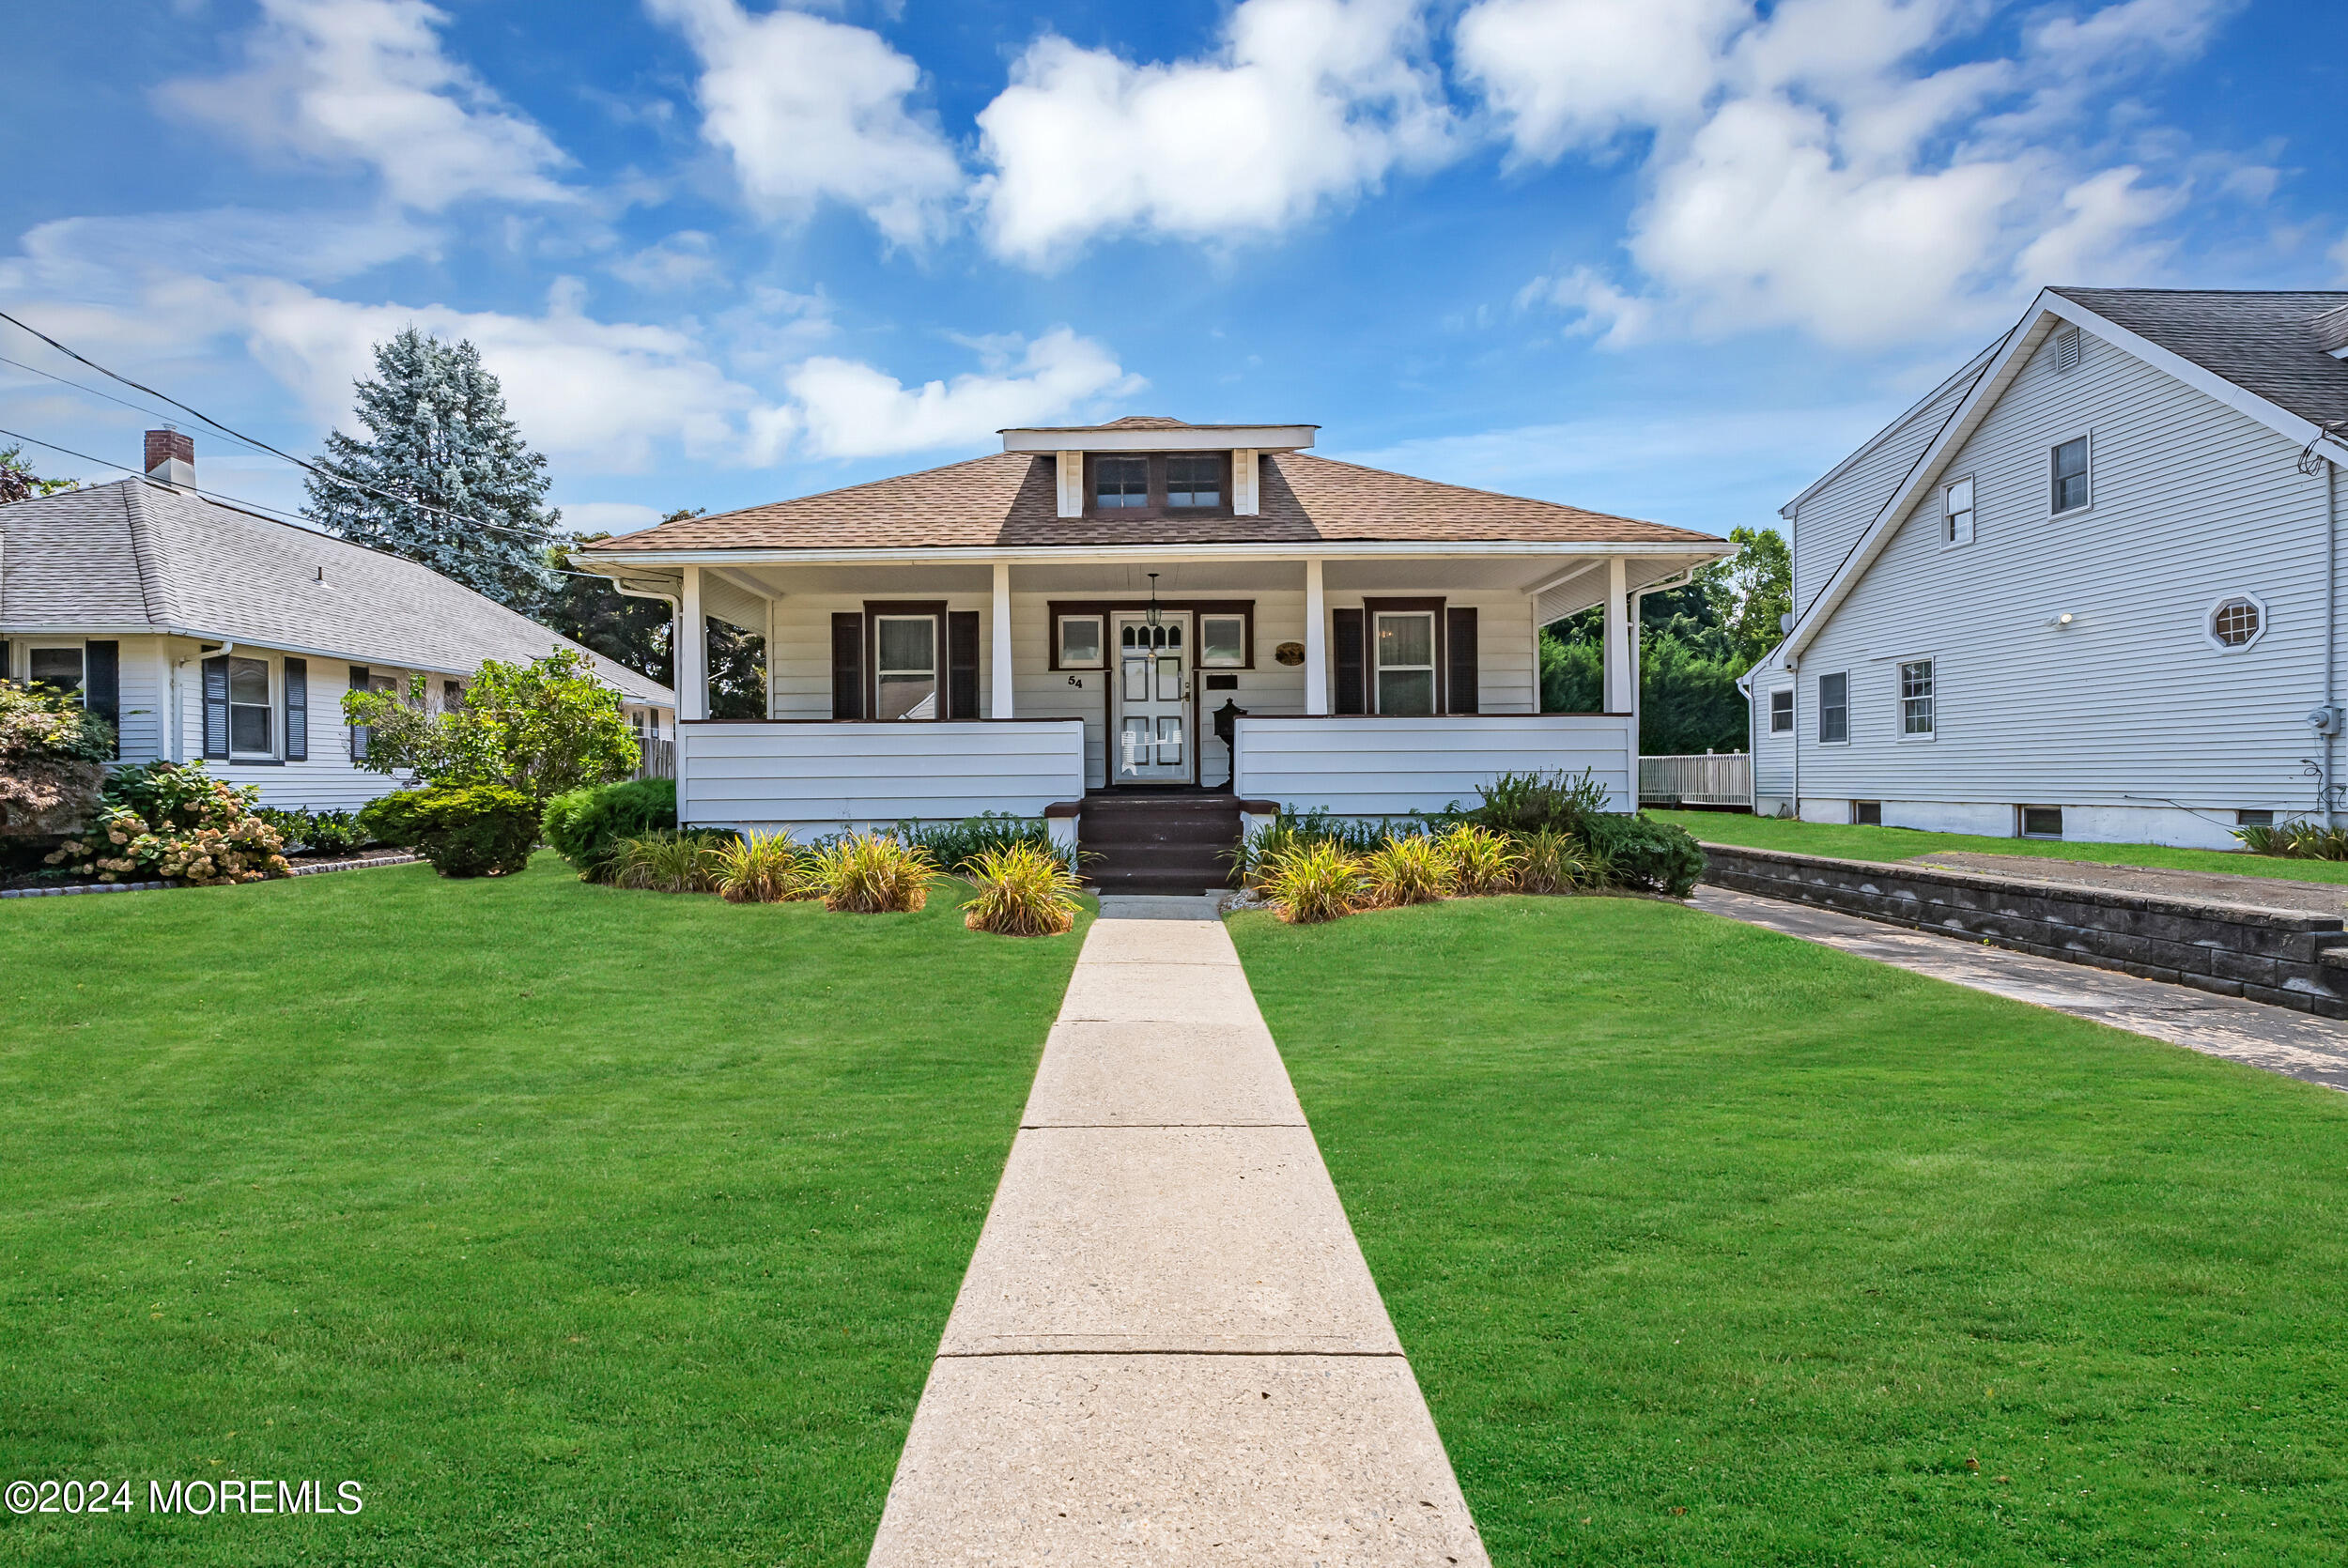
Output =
[{"x1": 1784, "y1": 319, "x2": 2327, "y2": 822}]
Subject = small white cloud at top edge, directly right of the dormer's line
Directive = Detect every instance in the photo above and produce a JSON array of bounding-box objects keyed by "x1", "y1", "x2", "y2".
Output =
[{"x1": 1459, "y1": 0, "x2": 1752, "y2": 160}]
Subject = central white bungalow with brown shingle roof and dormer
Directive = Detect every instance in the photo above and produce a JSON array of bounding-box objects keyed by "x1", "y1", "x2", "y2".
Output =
[{"x1": 580, "y1": 418, "x2": 1728, "y2": 892}]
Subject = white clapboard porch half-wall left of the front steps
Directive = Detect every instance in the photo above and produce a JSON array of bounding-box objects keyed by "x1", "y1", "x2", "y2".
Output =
[{"x1": 676, "y1": 718, "x2": 1085, "y2": 834}]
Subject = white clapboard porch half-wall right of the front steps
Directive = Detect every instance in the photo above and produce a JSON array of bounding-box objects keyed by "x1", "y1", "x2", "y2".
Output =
[{"x1": 1238, "y1": 714, "x2": 1632, "y2": 817}]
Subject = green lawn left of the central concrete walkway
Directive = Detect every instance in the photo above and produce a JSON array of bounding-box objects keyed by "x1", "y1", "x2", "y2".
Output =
[{"x1": 0, "y1": 857, "x2": 1078, "y2": 1568}]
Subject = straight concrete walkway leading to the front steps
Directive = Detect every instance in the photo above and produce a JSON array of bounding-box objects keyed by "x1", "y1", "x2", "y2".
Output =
[{"x1": 872, "y1": 899, "x2": 1487, "y2": 1568}]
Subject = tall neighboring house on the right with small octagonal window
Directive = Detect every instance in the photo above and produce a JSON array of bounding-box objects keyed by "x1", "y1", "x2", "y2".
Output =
[{"x1": 1745, "y1": 289, "x2": 2348, "y2": 848}]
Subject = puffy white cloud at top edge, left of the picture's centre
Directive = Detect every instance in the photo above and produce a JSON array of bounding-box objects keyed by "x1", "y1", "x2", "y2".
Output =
[{"x1": 648, "y1": 0, "x2": 963, "y2": 244}]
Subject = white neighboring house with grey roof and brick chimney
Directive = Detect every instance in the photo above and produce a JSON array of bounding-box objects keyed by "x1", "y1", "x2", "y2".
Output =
[{"x1": 0, "y1": 430, "x2": 676, "y2": 810}]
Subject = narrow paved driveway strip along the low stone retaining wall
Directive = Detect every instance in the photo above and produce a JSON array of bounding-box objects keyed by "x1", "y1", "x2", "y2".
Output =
[{"x1": 1689, "y1": 887, "x2": 2348, "y2": 1089}]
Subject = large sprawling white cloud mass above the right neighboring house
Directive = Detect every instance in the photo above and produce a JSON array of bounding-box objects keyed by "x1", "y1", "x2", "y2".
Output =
[{"x1": 1460, "y1": 0, "x2": 2238, "y2": 347}]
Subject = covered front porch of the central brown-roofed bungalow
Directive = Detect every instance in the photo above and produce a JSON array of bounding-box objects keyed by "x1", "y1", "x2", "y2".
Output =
[{"x1": 615, "y1": 543, "x2": 1714, "y2": 840}]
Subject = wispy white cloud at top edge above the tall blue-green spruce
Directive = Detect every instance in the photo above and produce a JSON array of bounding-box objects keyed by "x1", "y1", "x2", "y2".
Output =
[{"x1": 160, "y1": 0, "x2": 571, "y2": 211}]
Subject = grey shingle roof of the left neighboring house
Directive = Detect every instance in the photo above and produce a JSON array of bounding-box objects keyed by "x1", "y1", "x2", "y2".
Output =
[{"x1": 0, "y1": 479, "x2": 674, "y2": 704}]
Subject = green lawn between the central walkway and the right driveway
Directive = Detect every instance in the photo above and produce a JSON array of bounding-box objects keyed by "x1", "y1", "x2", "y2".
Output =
[{"x1": 1233, "y1": 892, "x2": 2348, "y2": 1568}]
